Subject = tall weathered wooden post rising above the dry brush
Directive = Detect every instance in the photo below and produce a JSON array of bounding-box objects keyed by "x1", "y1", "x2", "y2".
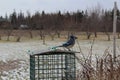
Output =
[{"x1": 113, "y1": 2, "x2": 117, "y2": 61}]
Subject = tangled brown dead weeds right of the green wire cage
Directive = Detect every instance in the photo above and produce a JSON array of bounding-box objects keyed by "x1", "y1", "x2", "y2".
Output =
[{"x1": 76, "y1": 53, "x2": 120, "y2": 80}]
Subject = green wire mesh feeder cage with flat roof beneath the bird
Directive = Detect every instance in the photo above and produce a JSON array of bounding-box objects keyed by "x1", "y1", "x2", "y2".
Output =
[{"x1": 30, "y1": 51, "x2": 76, "y2": 80}]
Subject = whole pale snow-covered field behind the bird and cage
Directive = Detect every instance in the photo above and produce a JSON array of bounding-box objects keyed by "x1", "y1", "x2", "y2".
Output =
[{"x1": 0, "y1": 40, "x2": 120, "y2": 80}]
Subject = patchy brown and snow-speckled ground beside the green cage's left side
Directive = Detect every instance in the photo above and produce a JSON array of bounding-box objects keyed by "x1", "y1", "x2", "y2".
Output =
[{"x1": 0, "y1": 59, "x2": 29, "y2": 80}]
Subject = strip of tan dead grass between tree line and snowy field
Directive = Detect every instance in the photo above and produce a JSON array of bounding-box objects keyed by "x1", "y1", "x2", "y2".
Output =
[{"x1": 0, "y1": 30, "x2": 115, "y2": 41}]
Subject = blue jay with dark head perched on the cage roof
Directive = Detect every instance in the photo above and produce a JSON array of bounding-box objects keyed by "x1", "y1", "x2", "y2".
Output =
[{"x1": 53, "y1": 35, "x2": 77, "y2": 51}]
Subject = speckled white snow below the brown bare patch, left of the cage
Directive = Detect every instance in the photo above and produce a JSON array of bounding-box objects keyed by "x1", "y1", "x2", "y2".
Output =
[{"x1": 0, "y1": 62, "x2": 30, "y2": 80}]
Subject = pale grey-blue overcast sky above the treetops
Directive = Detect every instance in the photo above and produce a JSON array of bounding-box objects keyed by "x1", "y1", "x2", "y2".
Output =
[{"x1": 0, "y1": 0, "x2": 120, "y2": 16}]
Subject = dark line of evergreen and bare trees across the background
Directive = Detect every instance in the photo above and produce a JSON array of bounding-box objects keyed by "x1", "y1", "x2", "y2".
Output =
[{"x1": 0, "y1": 8, "x2": 120, "y2": 40}]
